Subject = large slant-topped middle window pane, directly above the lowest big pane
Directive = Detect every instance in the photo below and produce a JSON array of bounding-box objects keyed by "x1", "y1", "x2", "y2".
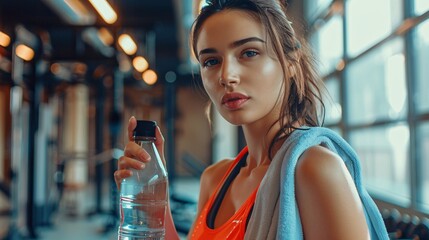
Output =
[{"x1": 346, "y1": 38, "x2": 407, "y2": 124}]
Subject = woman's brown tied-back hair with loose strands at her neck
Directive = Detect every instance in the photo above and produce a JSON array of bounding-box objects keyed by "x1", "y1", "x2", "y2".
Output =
[{"x1": 190, "y1": 0, "x2": 325, "y2": 158}]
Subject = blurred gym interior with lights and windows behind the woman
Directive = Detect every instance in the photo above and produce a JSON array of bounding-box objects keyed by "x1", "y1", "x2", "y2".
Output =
[{"x1": 0, "y1": 0, "x2": 429, "y2": 240}]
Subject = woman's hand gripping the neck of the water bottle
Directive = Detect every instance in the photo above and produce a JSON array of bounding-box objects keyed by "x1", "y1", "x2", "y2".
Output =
[{"x1": 114, "y1": 117, "x2": 165, "y2": 189}]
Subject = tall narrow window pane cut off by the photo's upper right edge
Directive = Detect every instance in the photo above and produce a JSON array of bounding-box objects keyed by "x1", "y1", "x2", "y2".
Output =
[{"x1": 415, "y1": 19, "x2": 429, "y2": 112}]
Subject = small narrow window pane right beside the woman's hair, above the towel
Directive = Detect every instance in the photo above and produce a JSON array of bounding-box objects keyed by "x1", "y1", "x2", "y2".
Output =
[{"x1": 324, "y1": 78, "x2": 342, "y2": 124}]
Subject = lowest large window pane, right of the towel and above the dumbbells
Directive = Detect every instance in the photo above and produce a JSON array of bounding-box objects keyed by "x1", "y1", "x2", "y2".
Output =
[{"x1": 350, "y1": 124, "x2": 410, "y2": 205}]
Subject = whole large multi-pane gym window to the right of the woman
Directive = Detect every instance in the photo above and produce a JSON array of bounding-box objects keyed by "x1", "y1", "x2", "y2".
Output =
[{"x1": 305, "y1": 0, "x2": 429, "y2": 214}]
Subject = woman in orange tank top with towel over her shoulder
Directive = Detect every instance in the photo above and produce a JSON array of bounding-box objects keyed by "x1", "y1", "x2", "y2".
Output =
[{"x1": 115, "y1": 0, "x2": 388, "y2": 239}]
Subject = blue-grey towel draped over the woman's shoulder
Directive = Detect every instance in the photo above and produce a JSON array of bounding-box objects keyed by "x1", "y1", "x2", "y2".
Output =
[{"x1": 245, "y1": 127, "x2": 389, "y2": 240}]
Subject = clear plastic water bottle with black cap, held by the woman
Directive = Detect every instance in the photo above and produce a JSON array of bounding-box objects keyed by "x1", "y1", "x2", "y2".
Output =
[{"x1": 118, "y1": 120, "x2": 168, "y2": 240}]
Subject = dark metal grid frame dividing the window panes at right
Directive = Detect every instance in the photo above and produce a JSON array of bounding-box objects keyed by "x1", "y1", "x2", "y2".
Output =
[{"x1": 304, "y1": 0, "x2": 429, "y2": 214}]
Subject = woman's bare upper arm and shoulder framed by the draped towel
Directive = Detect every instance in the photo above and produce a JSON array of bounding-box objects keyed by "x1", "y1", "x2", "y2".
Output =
[{"x1": 295, "y1": 146, "x2": 370, "y2": 240}]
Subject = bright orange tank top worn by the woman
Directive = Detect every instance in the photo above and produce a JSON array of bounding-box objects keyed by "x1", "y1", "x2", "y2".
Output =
[{"x1": 191, "y1": 147, "x2": 258, "y2": 240}]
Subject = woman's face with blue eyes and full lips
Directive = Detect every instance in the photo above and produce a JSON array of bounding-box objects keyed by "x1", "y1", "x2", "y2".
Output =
[{"x1": 197, "y1": 10, "x2": 284, "y2": 125}]
